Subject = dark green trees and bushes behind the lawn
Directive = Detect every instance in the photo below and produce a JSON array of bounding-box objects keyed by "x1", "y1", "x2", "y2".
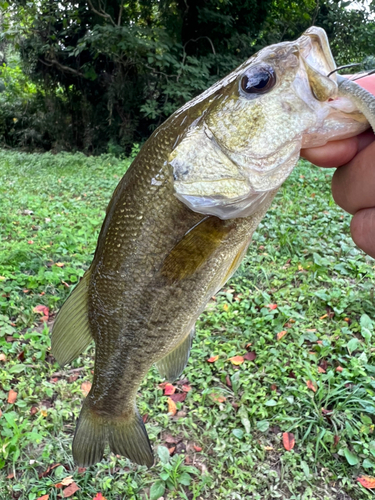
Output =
[{"x1": 0, "y1": 0, "x2": 374, "y2": 154}]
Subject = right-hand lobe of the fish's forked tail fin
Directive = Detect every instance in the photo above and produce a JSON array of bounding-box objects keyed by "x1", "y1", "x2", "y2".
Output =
[{"x1": 107, "y1": 408, "x2": 154, "y2": 467}]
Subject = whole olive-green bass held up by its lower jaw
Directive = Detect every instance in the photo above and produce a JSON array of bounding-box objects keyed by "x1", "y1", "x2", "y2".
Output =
[{"x1": 52, "y1": 27, "x2": 369, "y2": 467}]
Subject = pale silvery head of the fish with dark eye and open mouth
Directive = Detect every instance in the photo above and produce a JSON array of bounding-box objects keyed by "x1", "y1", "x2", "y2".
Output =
[{"x1": 168, "y1": 27, "x2": 368, "y2": 219}]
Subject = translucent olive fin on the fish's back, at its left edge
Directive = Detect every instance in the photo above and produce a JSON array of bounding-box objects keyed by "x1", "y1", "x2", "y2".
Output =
[{"x1": 51, "y1": 270, "x2": 92, "y2": 366}]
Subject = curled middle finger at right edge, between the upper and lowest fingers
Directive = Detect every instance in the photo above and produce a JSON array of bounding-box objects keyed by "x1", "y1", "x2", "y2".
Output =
[{"x1": 332, "y1": 142, "x2": 375, "y2": 214}]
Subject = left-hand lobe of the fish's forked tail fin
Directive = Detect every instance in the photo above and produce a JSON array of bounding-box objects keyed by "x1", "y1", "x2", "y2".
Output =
[{"x1": 72, "y1": 399, "x2": 107, "y2": 467}]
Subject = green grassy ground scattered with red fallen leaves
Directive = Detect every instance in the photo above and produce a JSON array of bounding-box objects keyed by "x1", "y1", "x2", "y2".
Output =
[{"x1": 0, "y1": 151, "x2": 375, "y2": 500}]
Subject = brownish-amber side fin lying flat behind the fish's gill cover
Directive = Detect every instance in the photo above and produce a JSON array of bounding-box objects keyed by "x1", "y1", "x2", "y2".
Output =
[{"x1": 161, "y1": 216, "x2": 233, "y2": 281}]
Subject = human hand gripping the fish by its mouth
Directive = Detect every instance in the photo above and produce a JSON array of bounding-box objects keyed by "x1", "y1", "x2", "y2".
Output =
[{"x1": 301, "y1": 75, "x2": 375, "y2": 258}]
